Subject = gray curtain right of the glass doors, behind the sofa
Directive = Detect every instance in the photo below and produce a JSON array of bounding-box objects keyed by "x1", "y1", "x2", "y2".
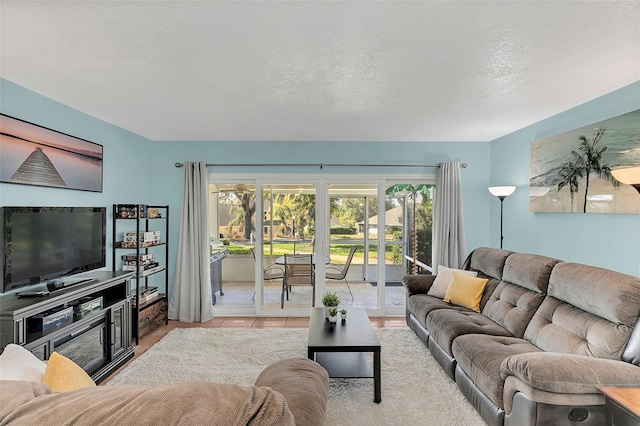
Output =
[{"x1": 432, "y1": 162, "x2": 466, "y2": 273}]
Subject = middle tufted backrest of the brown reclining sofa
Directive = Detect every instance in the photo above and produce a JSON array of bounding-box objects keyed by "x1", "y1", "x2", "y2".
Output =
[{"x1": 482, "y1": 253, "x2": 558, "y2": 337}]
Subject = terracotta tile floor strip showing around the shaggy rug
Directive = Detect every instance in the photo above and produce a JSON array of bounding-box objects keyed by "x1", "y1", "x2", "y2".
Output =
[{"x1": 101, "y1": 316, "x2": 407, "y2": 384}]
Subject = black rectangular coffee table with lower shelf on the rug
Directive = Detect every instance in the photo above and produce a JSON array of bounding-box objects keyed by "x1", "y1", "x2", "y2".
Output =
[{"x1": 307, "y1": 307, "x2": 382, "y2": 403}]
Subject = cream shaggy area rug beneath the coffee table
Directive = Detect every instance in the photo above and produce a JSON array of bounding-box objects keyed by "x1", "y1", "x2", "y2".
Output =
[{"x1": 106, "y1": 328, "x2": 484, "y2": 426}]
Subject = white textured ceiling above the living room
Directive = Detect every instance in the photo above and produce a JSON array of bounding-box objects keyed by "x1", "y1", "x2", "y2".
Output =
[{"x1": 0, "y1": 0, "x2": 640, "y2": 141}]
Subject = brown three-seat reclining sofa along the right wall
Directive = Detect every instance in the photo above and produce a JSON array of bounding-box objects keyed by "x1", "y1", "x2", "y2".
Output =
[{"x1": 404, "y1": 247, "x2": 640, "y2": 426}]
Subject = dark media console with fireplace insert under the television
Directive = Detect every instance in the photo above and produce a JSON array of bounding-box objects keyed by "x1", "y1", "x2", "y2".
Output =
[{"x1": 0, "y1": 271, "x2": 133, "y2": 383}]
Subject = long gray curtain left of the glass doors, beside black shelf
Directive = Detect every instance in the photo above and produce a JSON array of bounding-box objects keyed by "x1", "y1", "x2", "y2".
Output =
[{"x1": 169, "y1": 162, "x2": 213, "y2": 323}]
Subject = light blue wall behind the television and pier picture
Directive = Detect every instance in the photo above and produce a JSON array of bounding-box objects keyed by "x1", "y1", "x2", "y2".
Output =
[{"x1": 0, "y1": 79, "x2": 152, "y2": 280}]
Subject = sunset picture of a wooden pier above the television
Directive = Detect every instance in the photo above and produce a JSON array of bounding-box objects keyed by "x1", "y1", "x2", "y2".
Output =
[{"x1": 0, "y1": 114, "x2": 103, "y2": 192}]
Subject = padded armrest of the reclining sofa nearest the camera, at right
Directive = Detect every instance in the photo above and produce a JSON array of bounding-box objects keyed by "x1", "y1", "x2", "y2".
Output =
[{"x1": 500, "y1": 352, "x2": 640, "y2": 394}]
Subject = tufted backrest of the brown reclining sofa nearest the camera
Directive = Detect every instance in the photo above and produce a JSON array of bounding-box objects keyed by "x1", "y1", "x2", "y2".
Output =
[{"x1": 524, "y1": 262, "x2": 640, "y2": 360}]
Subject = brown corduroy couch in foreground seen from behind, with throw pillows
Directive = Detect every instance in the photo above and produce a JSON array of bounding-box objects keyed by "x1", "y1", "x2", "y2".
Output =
[{"x1": 0, "y1": 345, "x2": 329, "y2": 426}]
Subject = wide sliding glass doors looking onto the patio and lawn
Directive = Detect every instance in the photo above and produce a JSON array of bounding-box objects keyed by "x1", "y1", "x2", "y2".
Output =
[{"x1": 210, "y1": 175, "x2": 431, "y2": 316}]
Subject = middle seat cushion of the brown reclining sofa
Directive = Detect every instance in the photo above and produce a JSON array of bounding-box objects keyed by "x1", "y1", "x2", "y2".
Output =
[{"x1": 426, "y1": 309, "x2": 513, "y2": 356}]
